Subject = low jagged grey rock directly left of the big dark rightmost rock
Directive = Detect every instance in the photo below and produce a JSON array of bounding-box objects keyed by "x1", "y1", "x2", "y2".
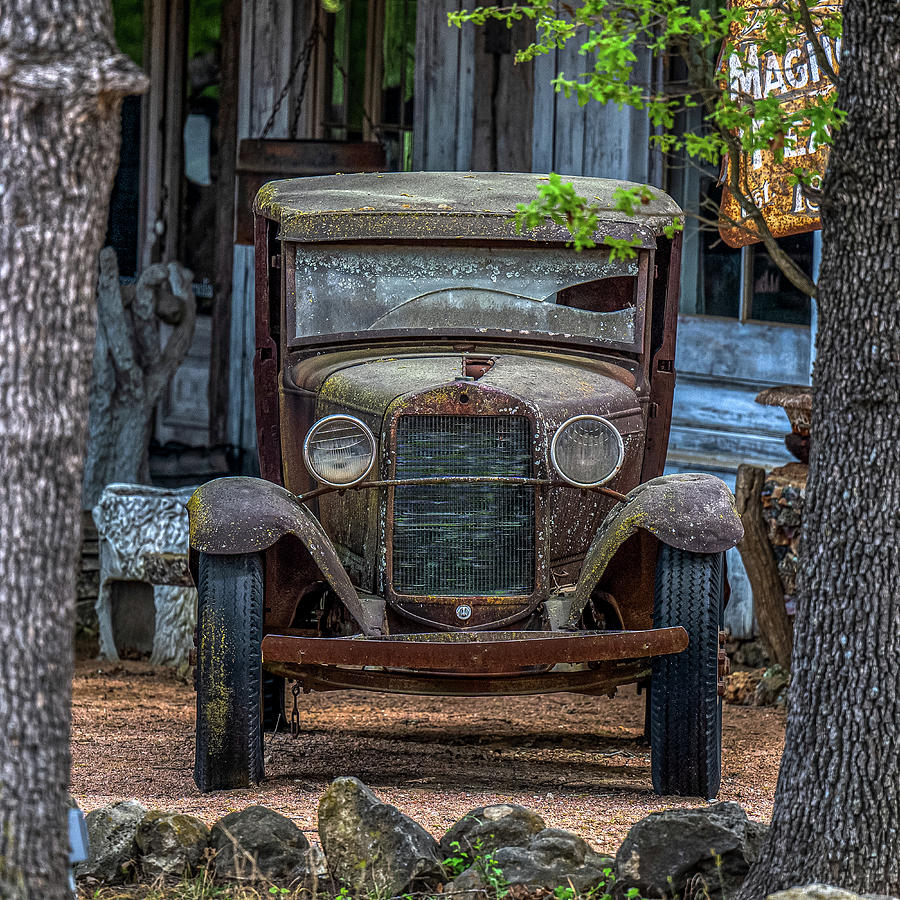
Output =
[{"x1": 446, "y1": 828, "x2": 615, "y2": 900}]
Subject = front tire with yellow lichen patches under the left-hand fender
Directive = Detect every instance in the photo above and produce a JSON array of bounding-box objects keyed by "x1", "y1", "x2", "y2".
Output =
[{"x1": 194, "y1": 553, "x2": 264, "y2": 792}]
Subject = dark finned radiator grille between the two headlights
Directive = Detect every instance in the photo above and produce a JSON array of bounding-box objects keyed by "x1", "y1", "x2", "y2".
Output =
[{"x1": 393, "y1": 416, "x2": 534, "y2": 597}]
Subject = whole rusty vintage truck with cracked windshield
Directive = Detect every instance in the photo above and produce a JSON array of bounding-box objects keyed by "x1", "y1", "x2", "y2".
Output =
[{"x1": 189, "y1": 173, "x2": 742, "y2": 797}]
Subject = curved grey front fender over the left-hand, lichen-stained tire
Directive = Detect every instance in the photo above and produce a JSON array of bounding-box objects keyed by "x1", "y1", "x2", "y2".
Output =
[{"x1": 187, "y1": 476, "x2": 378, "y2": 634}]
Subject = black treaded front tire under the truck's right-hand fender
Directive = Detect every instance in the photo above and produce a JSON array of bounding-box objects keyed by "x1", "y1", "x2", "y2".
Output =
[{"x1": 650, "y1": 544, "x2": 725, "y2": 800}]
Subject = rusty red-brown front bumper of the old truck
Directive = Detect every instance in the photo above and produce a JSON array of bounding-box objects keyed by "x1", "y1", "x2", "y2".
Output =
[{"x1": 262, "y1": 627, "x2": 688, "y2": 675}]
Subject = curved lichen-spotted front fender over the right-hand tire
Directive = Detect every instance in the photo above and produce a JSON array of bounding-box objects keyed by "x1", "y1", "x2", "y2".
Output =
[{"x1": 568, "y1": 473, "x2": 744, "y2": 625}]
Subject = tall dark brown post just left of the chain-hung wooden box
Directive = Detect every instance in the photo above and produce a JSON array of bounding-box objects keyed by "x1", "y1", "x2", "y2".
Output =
[{"x1": 208, "y1": 0, "x2": 241, "y2": 445}]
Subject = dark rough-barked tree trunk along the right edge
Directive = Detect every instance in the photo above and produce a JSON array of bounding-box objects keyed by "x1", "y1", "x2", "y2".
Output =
[{"x1": 742, "y1": 0, "x2": 900, "y2": 900}]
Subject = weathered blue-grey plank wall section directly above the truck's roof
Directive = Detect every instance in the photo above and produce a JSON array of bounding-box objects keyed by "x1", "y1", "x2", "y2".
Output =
[{"x1": 414, "y1": 0, "x2": 659, "y2": 181}]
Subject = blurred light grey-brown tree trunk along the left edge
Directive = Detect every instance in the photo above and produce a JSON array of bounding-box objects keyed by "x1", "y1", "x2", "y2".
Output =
[{"x1": 0, "y1": 0, "x2": 145, "y2": 900}]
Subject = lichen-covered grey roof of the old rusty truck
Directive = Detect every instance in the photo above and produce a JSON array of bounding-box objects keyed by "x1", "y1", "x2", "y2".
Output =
[{"x1": 254, "y1": 172, "x2": 684, "y2": 247}]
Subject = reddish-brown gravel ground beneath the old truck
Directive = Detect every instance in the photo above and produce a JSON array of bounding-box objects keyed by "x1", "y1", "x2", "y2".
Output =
[{"x1": 72, "y1": 661, "x2": 784, "y2": 852}]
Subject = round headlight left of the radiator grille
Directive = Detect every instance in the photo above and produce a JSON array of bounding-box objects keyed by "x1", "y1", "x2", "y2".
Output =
[{"x1": 303, "y1": 416, "x2": 375, "y2": 487}]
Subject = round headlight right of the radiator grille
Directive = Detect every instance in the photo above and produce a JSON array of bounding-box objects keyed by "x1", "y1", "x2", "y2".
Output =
[{"x1": 550, "y1": 416, "x2": 625, "y2": 487}]
